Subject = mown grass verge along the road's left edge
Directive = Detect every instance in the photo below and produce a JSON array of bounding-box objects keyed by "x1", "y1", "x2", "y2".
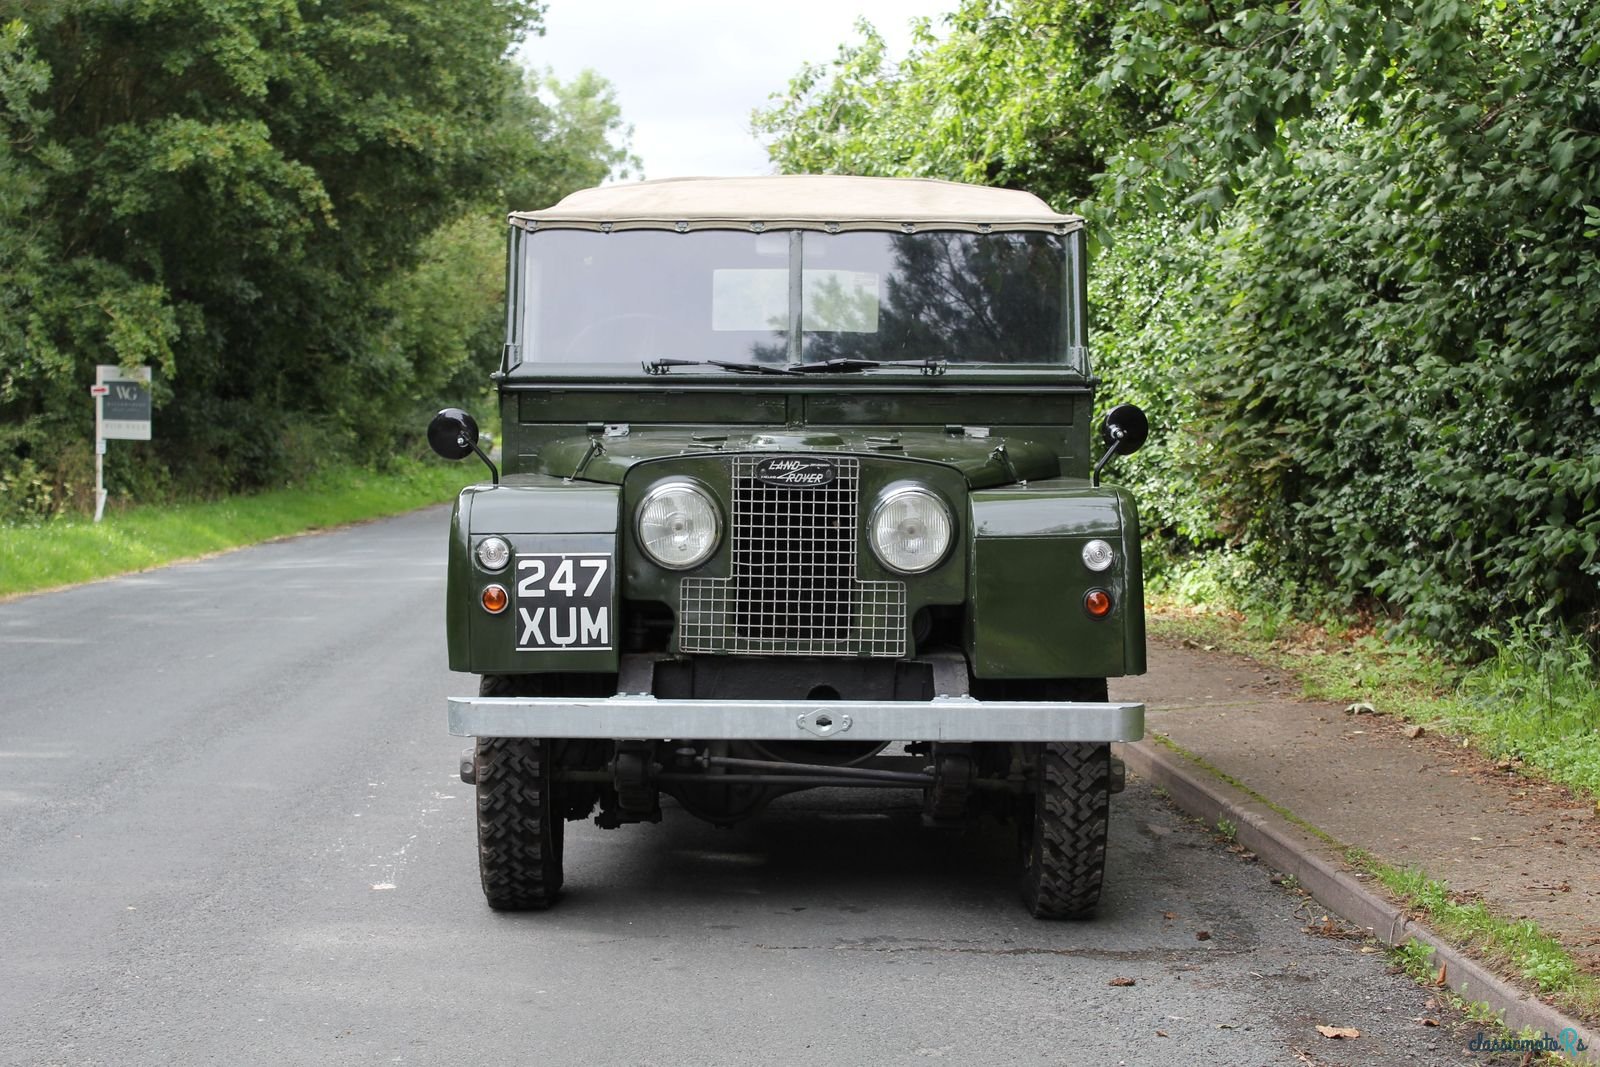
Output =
[{"x1": 0, "y1": 461, "x2": 480, "y2": 597}]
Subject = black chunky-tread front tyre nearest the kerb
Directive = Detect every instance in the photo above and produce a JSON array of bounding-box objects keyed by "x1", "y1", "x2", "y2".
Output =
[{"x1": 1019, "y1": 741, "x2": 1110, "y2": 918}]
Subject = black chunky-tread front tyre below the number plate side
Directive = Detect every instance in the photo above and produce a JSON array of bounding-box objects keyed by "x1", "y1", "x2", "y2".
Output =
[{"x1": 474, "y1": 675, "x2": 563, "y2": 912}]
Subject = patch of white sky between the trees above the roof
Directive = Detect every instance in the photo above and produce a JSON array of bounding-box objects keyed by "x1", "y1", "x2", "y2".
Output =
[{"x1": 522, "y1": 0, "x2": 957, "y2": 178}]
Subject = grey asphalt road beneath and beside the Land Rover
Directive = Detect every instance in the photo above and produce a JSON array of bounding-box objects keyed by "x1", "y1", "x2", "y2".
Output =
[{"x1": 0, "y1": 509, "x2": 1493, "y2": 1065}]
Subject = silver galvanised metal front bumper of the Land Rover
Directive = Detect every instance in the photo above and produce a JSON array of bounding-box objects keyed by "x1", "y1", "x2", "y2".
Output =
[{"x1": 450, "y1": 696, "x2": 1144, "y2": 741}]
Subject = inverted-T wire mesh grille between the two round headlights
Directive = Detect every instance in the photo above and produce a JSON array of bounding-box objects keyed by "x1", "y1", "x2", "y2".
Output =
[{"x1": 678, "y1": 456, "x2": 906, "y2": 656}]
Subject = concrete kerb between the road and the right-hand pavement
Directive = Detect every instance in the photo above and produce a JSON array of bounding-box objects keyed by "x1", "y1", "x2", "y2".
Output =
[{"x1": 1118, "y1": 741, "x2": 1600, "y2": 1064}]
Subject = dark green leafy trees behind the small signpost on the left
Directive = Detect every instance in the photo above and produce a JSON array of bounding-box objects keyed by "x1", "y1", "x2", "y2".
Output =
[{"x1": 0, "y1": 0, "x2": 635, "y2": 515}]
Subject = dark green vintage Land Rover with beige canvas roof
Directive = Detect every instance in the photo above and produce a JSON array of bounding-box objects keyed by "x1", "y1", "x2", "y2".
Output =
[{"x1": 429, "y1": 176, "x2": 1147, "y2": 918}]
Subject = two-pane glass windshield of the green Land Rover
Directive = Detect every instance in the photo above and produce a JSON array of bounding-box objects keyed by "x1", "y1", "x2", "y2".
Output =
[{"x1": 514, "y1": 229, "x2": 1070, "y2": 365}]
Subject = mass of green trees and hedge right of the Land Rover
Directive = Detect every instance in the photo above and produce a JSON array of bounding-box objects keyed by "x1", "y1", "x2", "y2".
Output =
[{"x1": 757, "y1": 0, "x2": 1600, "y2": 645}]
